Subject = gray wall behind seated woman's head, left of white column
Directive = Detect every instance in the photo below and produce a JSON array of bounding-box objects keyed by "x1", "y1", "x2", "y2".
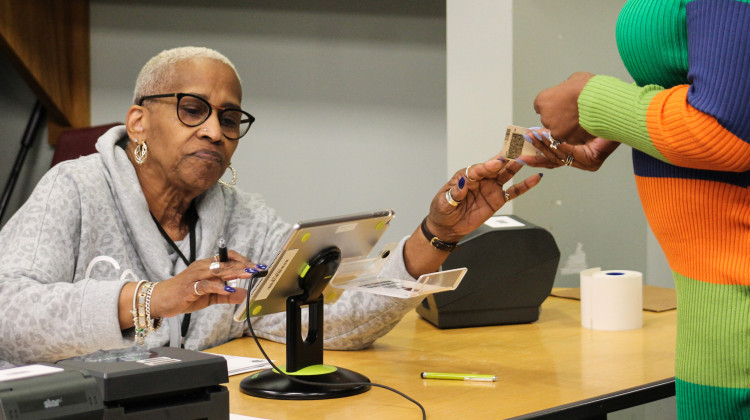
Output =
[{"x1": 91, "y1": 0, "x2": 446, "y2": 243}]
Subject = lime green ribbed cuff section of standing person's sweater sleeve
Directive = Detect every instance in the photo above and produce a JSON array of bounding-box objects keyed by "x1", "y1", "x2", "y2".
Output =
[{"x1": 578, "y1": 75, "x2": 668, "y2": 162}]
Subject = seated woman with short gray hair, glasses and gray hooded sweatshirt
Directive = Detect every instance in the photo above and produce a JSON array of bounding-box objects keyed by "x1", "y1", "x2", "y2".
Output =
[{"x1": 0, "y1": 47, "x2": 541, "y2": 364}]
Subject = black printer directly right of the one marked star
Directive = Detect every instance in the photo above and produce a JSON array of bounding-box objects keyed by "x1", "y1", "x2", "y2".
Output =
[{"x1": 55, "y1": 347, "x2": 229, "y2": 420}]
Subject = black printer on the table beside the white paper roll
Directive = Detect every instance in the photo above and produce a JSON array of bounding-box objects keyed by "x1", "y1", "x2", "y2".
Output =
[{"x1": 417, "y1": 216, "x2": 560, "y2": 328}]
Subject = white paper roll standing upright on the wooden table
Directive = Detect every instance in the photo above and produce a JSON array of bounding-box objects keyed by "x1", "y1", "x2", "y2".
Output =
[{"x1": 581, "y1": 267, "x2": 643, "y2": 331}]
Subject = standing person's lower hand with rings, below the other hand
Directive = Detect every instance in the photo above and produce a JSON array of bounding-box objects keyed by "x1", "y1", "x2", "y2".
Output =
[{"x1": 521, "y1": 129, "x2": 620, "y2": 172}]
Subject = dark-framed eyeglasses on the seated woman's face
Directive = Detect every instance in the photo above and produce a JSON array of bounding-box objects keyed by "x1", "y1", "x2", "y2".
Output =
[{"x1": 138, "y1": 93, "x2": 255, "y2": 140}]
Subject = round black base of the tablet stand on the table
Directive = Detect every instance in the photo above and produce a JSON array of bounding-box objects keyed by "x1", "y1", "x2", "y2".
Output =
[{"x1": 240, "y1": 365, "x2": 370, "y2": 400}]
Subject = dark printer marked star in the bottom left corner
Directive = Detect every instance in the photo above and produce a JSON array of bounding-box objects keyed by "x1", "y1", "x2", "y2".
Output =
[{"x1": 0, "y1": 364, "x2": 104, "y2": 420}]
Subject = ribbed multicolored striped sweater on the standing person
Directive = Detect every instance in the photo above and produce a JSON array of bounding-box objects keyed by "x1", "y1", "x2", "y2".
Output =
[{"x1": 578, "y1": 0, "x2": 750, "y2": 419}]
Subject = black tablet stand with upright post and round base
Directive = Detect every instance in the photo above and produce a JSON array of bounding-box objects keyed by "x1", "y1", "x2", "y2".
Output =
[{"x1": 240, "y1": 247, "x2": 370, "y2": 400}]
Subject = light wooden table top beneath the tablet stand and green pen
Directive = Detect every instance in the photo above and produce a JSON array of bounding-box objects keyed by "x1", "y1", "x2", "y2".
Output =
[{"x1": 211, "y1": 297, "x2": 676, "y2": 420}]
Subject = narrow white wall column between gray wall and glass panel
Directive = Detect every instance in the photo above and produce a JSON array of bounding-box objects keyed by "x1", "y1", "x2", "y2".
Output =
[{"x1": 446, "y1": 0, "x2": 516, "y2": 218}]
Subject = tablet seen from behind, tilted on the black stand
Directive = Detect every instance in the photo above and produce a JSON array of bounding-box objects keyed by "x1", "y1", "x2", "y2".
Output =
[{"x1": 234, "y1": 209, "x2": 395, "y2": 322}]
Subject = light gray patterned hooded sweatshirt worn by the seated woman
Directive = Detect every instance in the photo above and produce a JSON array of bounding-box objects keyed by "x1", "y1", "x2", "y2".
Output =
[{"x1": 0, "y1": 126, "x2": 419, "y2": 367}]
